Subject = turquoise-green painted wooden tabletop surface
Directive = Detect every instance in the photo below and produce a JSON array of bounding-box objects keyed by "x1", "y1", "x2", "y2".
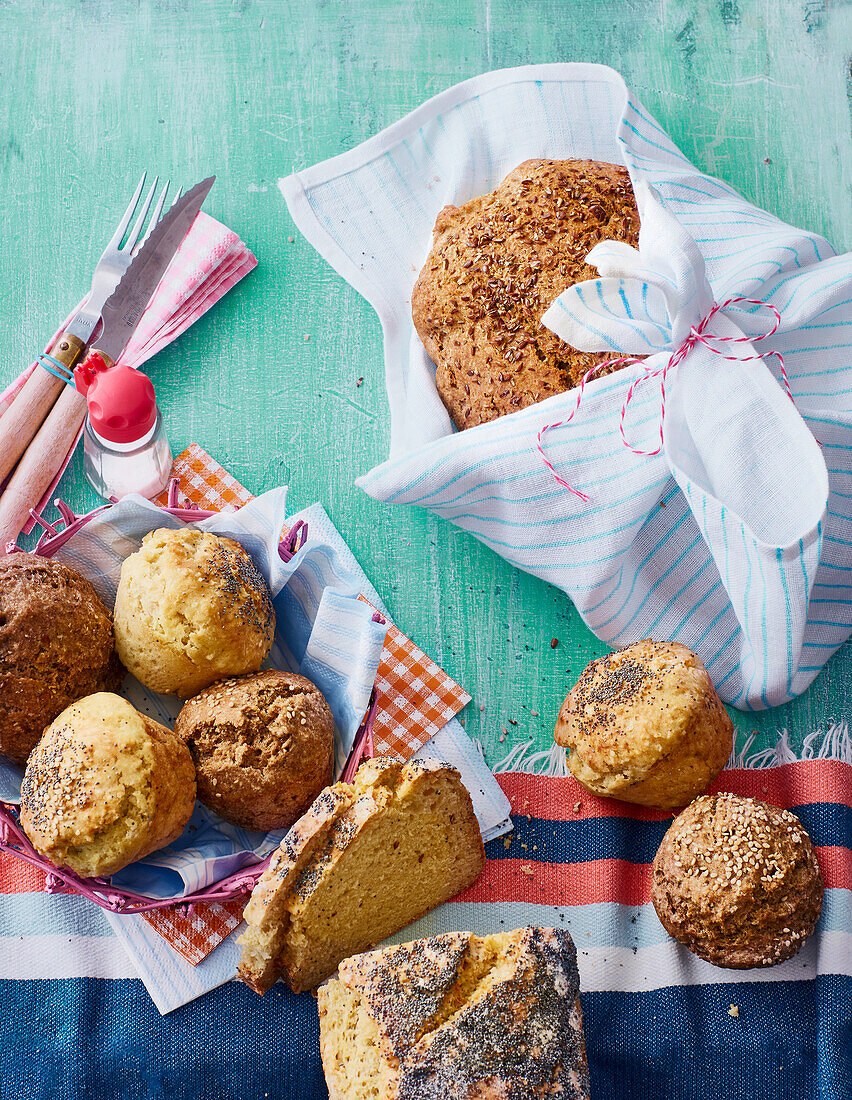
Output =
[{"x1": 0, "y1": 0, "x2": 852, "y2": 760}]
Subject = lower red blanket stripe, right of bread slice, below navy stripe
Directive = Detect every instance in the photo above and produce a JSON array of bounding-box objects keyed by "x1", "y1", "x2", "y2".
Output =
[{"x1": 453, "y1": 846, "x2": 852, "y2": 905}]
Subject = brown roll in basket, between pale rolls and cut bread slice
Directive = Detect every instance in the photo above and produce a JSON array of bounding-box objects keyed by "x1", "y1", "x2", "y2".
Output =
[{"x1": 175, "y1": 669, "x2": 334, "y2": 832}]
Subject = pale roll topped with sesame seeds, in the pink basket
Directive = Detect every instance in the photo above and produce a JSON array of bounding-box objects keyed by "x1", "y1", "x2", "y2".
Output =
[{"x1": 21, "y1": 692, "x2": 196, "y2": 877}]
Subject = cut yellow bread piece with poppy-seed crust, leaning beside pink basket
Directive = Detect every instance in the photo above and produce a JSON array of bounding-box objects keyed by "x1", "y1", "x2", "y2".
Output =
[{"x1": 239, "y1": 757, "x2": 485, "y2": 993}]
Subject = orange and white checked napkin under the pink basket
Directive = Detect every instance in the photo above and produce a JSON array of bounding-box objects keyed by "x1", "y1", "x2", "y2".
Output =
[{"x1": 135, "y1": 443, "x2": 471, "y2": 966}]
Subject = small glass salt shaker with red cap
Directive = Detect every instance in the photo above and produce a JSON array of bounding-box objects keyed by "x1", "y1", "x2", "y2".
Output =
[{"x1": 75, "y1": 353, "x2": 171, "y2": 501}]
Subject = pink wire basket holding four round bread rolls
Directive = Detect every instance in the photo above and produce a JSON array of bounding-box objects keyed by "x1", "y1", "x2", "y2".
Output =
[{"x1": 0, "y1": 477, "x2": 385, "y2": 915}]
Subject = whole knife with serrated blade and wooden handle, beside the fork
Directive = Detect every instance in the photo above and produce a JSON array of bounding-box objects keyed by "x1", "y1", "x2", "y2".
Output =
[{"x1": 0, "y1": 176, "x2": 215, "y2": 553}]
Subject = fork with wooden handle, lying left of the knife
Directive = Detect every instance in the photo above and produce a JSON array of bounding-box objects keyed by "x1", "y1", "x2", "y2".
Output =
[{"x1": 0, "y1": 173, "x2": 180, "y2": 482}]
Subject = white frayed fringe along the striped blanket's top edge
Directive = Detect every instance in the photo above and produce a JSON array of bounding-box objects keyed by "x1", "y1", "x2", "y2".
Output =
[{"x1": 493, "y1": 722, "x2": 852, "y2": 779}]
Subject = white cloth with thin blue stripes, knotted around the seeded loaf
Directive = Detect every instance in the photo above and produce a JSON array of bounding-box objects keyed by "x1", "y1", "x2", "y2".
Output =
[{"x1": 280, "y1": 65, "x2": 852, "y2": 708}]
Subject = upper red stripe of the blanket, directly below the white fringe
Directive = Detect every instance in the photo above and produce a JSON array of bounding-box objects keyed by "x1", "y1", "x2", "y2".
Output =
[{"x1": 497, "y1": 760, "x2": 852, "y2": 822}]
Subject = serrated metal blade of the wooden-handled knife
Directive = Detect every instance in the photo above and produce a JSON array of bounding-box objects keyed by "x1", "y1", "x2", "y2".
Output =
[{"x1": 96, "y1": 176, "x2": 215, "y2": 363}]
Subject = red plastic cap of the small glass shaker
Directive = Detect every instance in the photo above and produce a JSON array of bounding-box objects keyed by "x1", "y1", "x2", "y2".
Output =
[{"x1": 74, "y1": 352, "x2": 157, "y2": 443}]
